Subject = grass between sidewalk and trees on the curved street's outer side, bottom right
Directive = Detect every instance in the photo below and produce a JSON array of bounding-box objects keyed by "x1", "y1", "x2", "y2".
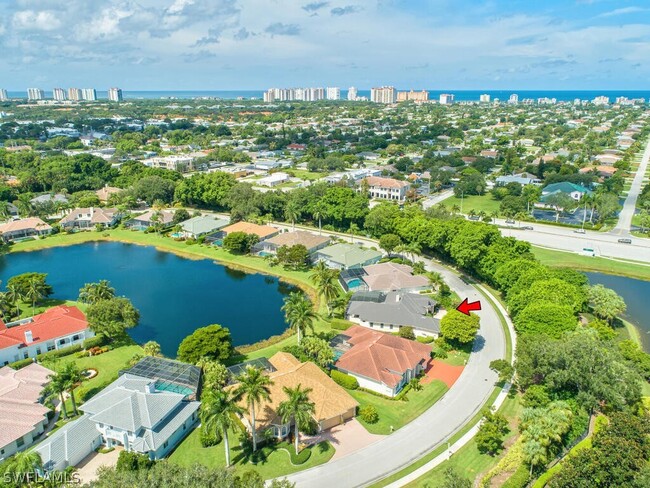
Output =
[{"x1": 406, "y1": 395, "x2": 521, "y2": 488}]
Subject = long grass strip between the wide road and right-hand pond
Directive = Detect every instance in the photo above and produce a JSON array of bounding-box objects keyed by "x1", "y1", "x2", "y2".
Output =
[{"x1": 533, "y1": 246, "x2": 650, "y2": 281}]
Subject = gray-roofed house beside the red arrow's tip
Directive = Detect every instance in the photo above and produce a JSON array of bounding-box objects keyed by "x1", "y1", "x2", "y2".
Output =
[{"x1": 345, "y1": 291, "x2": 440, "y2": 337}]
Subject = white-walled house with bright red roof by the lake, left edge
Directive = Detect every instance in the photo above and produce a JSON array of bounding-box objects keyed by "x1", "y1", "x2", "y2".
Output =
[{"x1": 0, "y1": 305, "x2": 95, "y2": 365}]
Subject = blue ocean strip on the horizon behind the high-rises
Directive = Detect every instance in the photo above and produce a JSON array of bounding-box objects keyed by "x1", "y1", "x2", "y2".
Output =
[{"x1": 8, "y1": 87, "x2": 650, "y2": 102}]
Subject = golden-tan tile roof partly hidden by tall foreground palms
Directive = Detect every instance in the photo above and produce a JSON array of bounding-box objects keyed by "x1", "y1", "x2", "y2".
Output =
[{"x1": 233, "y1": 352, "x2": 359, "y2": 431}]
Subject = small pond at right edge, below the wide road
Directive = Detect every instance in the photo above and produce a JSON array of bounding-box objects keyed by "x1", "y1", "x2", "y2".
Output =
[{"x1": 585, "y1": 273, "x2": 650, "y2": 352}]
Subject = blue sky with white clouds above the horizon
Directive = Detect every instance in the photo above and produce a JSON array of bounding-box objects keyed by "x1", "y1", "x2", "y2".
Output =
[{"x1": 0, "y1": 0, "x2": 650, "y2": 90}]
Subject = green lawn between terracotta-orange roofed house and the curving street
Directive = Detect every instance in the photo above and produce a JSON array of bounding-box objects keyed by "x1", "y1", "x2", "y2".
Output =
[{"x1": 347, "y1": 380, "x2": 448, "y2": 435}]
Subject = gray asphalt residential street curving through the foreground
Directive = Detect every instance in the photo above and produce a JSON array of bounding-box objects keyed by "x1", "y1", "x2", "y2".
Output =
[{"x1": 280, "y1": 250, "x2": 506, "y2": 488}]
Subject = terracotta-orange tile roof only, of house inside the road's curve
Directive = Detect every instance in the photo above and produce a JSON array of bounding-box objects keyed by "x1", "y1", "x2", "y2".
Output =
[{"x1": 336, "y1": 325, "x2": 431, "y2": 388}]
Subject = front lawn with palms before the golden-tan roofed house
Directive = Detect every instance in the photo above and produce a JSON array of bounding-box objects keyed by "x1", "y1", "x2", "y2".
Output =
[{"x1": 169, "y1": 428, "x2": 335, "y2": 479}]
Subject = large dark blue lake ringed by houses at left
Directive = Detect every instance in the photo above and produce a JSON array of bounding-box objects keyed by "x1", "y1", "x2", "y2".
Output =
[{"x1": 0, "y1": 242, "x2": 295, "y2": 357}]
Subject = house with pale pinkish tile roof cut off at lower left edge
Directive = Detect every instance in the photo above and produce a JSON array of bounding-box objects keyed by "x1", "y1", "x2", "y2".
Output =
[{"x1": 0, "y1": 363, "x2": 53, "y2": 461}]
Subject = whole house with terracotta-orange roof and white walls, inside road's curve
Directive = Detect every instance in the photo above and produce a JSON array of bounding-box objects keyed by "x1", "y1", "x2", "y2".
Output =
[{"x1": 331, "y1": 325, "x2": 431, "y2": 397}]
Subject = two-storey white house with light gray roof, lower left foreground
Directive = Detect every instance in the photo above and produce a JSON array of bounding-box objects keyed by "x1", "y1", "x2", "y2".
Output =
[{"x1": 35, "y1": 373, "x2": 200, "y2": 471}]
